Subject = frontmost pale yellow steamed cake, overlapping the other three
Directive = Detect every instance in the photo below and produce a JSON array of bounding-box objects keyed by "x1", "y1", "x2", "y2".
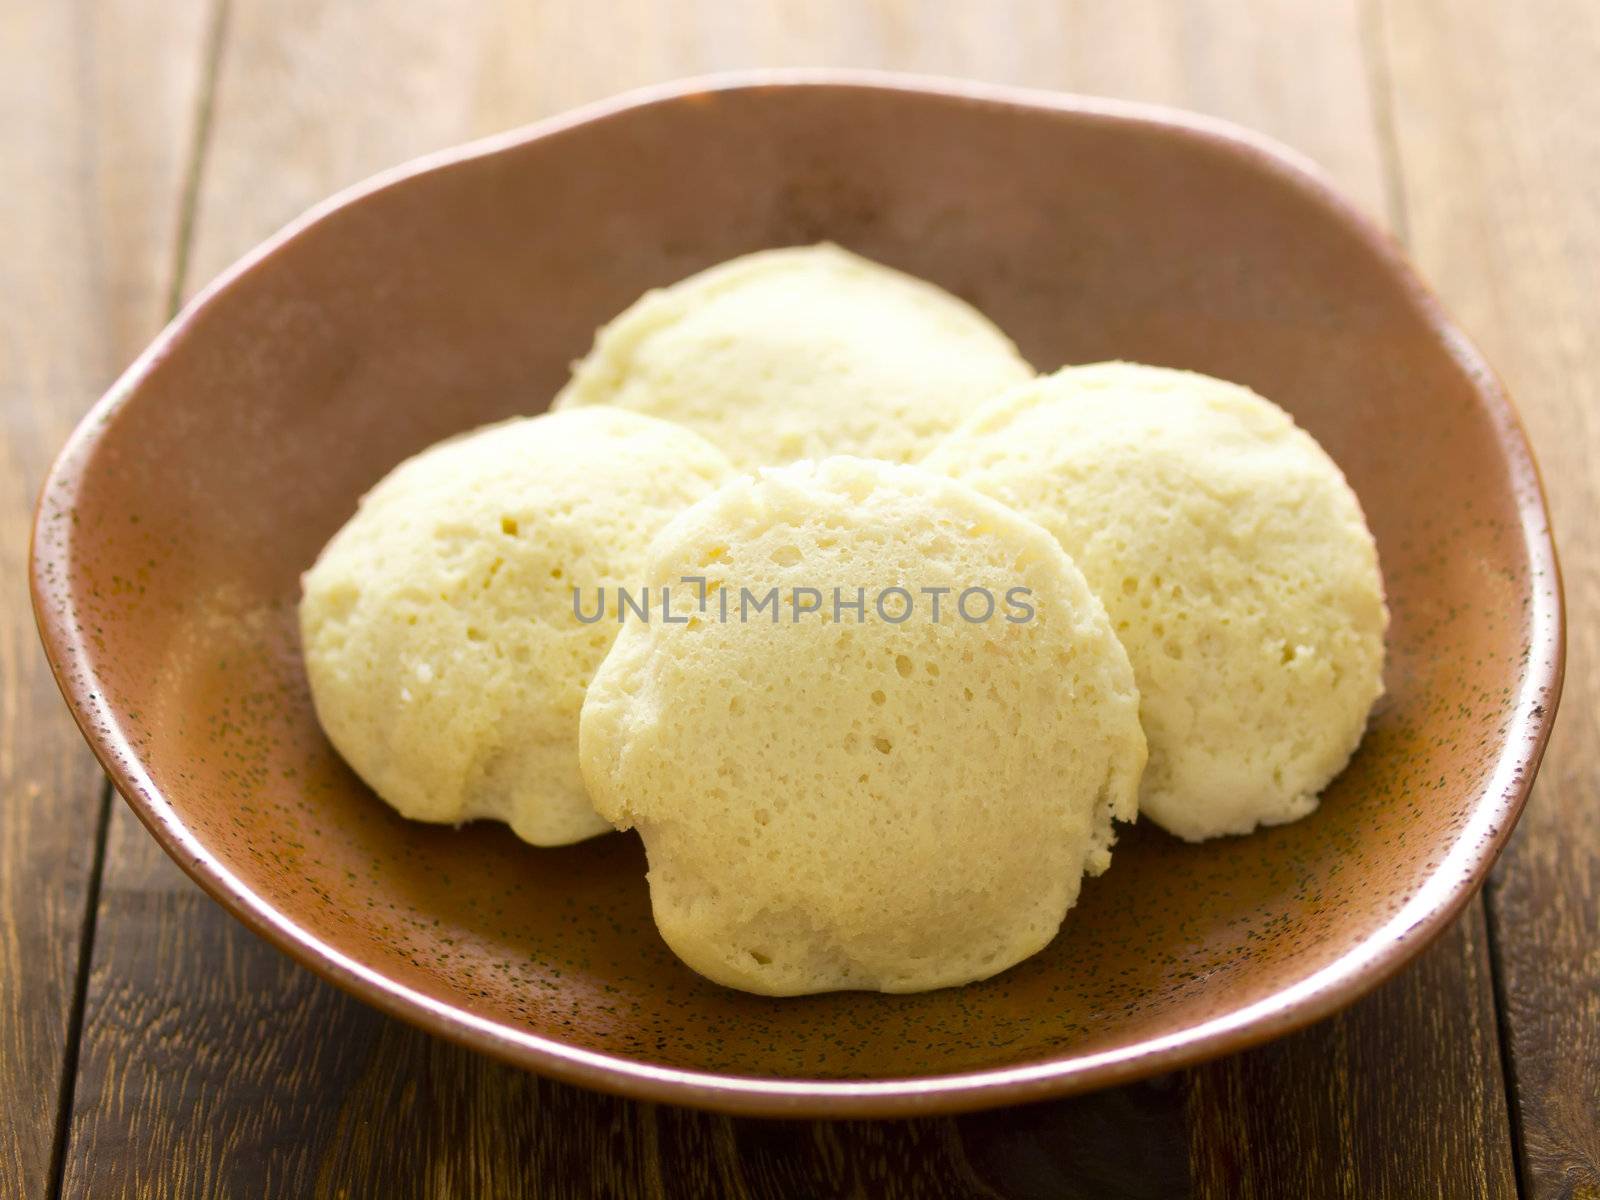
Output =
[{"x1": 581, "y1": 458, "x2": 1144, "y2": 995}]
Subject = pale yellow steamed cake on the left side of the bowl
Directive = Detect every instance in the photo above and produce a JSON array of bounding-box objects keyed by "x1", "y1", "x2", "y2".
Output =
[{"x1": 299, "y1": 408, "x2": 730, "y2": 845}]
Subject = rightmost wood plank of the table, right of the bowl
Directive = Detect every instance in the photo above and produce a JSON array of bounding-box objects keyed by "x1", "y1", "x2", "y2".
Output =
[{"x1": 1382, "y1": 0, "x2": 1600, "y2": 1197}]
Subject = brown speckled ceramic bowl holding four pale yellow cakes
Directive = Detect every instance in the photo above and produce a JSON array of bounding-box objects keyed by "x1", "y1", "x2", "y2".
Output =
[{"x1": 34, "y1": 74, "x2": 1562, "y2": 1115}]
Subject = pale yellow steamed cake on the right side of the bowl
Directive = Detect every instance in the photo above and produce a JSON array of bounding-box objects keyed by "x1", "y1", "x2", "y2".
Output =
[{"x1": 926, "y1": 363, "x2": 1389, "y2": 840}]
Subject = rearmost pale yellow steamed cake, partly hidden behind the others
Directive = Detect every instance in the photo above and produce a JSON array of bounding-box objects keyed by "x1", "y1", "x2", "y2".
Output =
[{"x1": 555, "y1": 245, "x2": 1034, "y2": 469}]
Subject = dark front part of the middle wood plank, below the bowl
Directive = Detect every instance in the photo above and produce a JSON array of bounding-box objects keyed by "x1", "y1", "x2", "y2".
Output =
[{"x1": 64, "y1": 805, "x2": 1515, "y2": 1200}]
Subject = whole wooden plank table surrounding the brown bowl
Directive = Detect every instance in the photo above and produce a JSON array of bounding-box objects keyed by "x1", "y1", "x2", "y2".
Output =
[{"x1": 0, "y1": 0, "x2": 1600, "y2": 1200}]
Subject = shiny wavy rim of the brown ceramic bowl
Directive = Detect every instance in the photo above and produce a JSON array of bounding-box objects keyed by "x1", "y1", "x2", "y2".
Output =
[{"x1": 29, "y1": 69, "x2": 1565, "y2": 1117}]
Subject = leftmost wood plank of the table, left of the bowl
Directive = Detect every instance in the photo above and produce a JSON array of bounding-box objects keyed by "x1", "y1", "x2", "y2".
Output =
[{"x1": 0, "y1": 0, "x2": 214, "y2": 1197}]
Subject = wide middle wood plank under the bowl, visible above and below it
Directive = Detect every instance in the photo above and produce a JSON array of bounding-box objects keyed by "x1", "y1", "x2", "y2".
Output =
[{"x1": 53, "y1": 0, "x2": 1510, "y2": 1197}]
